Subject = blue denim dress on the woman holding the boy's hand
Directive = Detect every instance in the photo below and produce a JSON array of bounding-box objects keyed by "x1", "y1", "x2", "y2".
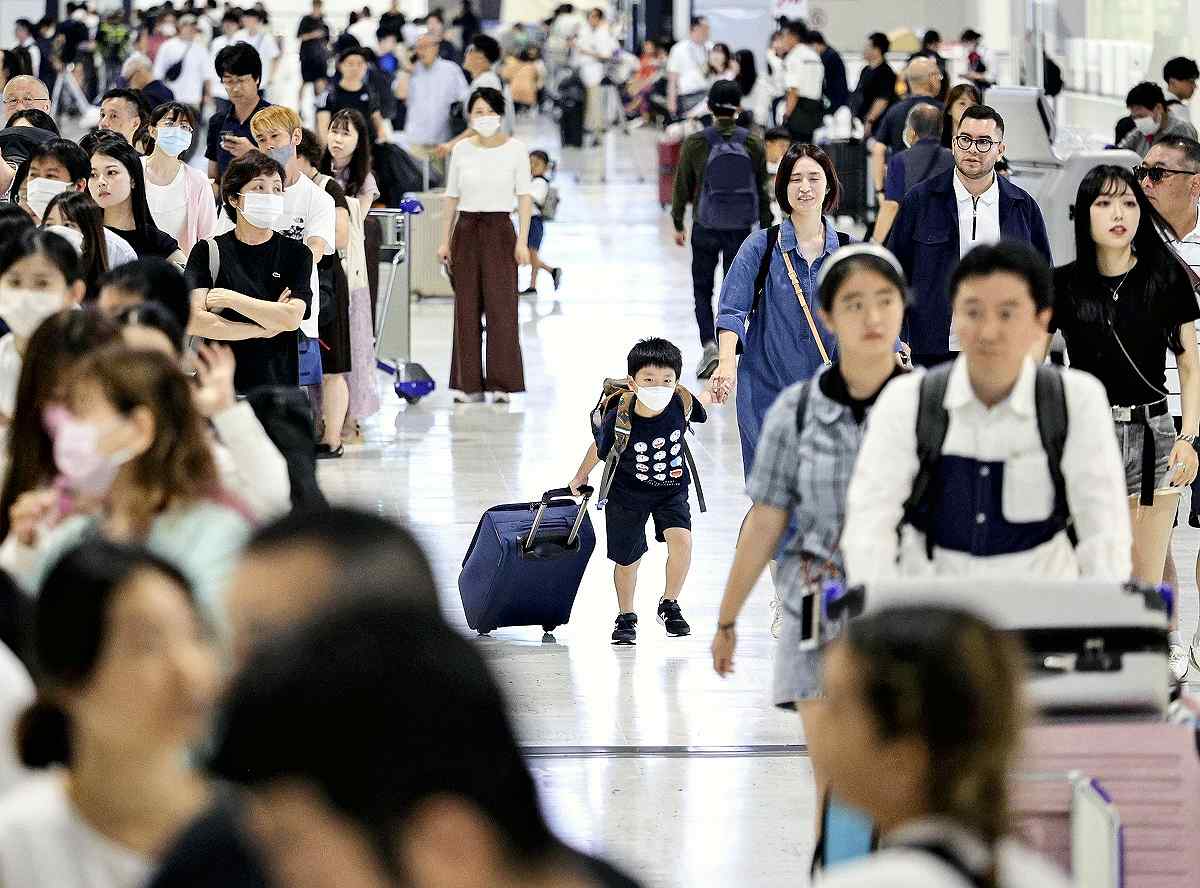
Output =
[{"x1": 716, "y1": 216, "x2": 838, "y2": 478}]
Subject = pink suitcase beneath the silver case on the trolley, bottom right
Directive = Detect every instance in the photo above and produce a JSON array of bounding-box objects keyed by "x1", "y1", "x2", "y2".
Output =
[{"x1": 1013, "y1": 719, "x2": 1200, "y2": 888}]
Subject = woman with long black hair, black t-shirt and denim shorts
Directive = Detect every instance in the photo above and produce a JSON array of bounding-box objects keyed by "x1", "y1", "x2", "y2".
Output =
[{"x1": 1050, "y1": 166, "x2": 1200, "y2": 602}]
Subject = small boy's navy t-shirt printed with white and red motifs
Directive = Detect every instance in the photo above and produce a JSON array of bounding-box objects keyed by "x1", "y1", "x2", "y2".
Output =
[{"x1": 595, "y1": 394, "x2": 708, "y2": 510}]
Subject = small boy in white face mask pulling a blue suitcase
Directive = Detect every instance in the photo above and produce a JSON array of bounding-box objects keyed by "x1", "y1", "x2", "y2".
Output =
[{"x1": 571, "y1": 338, "x2": 712, "y2": 644}]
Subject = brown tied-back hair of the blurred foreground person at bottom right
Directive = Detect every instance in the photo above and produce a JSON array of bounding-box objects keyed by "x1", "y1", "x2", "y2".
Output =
[{"x1": 845, "y1": 606, "x2": 1024, "y2": 876}]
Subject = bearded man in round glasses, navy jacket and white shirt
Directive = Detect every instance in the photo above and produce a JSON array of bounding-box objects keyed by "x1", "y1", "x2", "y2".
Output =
[{"x1": 887, "y1": 104, "x2": 1054, "y2": 367}]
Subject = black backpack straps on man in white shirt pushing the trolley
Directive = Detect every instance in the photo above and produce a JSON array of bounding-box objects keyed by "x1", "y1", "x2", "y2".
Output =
[{"x1": 902, "y1": 364, "x2": 1079, "y2": 558}]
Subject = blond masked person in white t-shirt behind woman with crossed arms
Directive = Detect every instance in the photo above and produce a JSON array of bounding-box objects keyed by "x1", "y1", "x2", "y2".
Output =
[{"x1": 216, "y1": 104, "x2": 336, "y2": 340}]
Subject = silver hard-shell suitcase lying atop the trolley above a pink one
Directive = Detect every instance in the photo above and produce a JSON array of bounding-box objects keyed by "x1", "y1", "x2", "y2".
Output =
[{"x1": 824, "y1": 577, "x2": 1170, "y2": 715}]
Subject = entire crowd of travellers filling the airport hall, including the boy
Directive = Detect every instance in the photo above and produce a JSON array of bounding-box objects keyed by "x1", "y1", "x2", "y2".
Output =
[{"x1": 0, "y1": 0, "x2": 1200, "y2": 888}]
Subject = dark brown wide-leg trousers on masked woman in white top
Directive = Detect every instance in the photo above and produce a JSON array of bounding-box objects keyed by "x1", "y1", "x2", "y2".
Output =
[{"x1": 450, "y1": 212, "x2": 524, "y2": 395}]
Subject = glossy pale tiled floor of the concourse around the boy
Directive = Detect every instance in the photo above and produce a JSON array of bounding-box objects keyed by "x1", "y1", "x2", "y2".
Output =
[{"x1": 322, "y1": 118, "x2": 1200, "y2": 888}]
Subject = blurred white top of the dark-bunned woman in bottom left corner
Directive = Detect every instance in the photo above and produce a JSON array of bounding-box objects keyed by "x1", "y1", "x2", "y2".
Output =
[{"x1": 0, "y1": 772, "x2": 154, "y2": 888}]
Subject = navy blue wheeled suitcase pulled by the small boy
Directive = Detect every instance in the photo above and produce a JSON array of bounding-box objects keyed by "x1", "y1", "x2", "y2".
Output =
[{"x1": 458, "y1": 487, "x2": 596, "y2": 635}]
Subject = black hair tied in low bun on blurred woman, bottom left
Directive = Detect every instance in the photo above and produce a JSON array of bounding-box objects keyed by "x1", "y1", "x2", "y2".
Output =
[{"x1": 17, "y1": 539, "x2": 196, "y2": 768}]
